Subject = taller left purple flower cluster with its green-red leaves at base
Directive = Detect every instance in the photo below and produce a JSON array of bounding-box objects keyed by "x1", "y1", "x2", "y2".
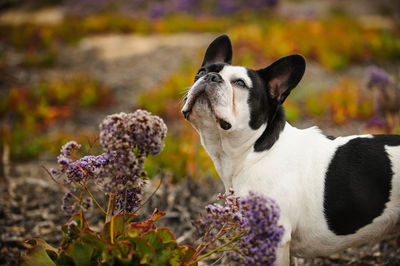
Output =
[{"x1": 21, "y1": 110, "x2": 195, "y2": 265}]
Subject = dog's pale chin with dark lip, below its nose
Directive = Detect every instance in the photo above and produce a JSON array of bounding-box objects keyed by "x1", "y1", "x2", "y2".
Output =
[{"x1": 182, "y1": 93, "x2": 232, "y2": 130}]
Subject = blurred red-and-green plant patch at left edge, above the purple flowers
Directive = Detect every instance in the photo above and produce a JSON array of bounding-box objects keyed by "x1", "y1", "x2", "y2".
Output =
[{"x1": 0, "y1": 75, "x2": 112, "y2": 159}]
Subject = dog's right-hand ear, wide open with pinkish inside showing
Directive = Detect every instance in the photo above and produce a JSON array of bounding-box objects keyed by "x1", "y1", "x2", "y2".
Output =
[{"x1": 257, "y1": 54, "x2": 306, "y2": 104}]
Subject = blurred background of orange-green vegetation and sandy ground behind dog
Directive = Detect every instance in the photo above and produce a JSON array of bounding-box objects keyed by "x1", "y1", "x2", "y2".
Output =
[{"x1": 0, "y1": 0, "x2": 400, "y2": 265}]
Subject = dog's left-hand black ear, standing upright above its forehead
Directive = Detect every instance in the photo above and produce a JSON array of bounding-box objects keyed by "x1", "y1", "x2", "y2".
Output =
[{"x1": 201, "y1": 34, "x2": 232, "y2": 67}]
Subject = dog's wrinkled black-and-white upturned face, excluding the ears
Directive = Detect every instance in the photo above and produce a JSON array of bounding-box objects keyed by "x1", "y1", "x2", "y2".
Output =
[{"x1": 182, "y1": 63, "x2": 253, "y2": 131}]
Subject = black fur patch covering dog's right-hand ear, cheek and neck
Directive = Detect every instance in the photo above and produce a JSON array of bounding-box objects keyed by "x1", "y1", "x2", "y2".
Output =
[{"x1": 247, "y1": 55, "x2": 305, "y2": 152}]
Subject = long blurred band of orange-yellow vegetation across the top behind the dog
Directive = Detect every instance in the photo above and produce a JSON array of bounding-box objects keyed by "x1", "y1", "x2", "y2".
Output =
[{"x1": 0, "y1": 12, "x2": 400, "y2": 70}]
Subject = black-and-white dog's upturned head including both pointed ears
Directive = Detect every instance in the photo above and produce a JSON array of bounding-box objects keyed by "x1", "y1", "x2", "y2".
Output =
[{"x1": 182, "y1": 35, "x2": 305, "y2": 151}]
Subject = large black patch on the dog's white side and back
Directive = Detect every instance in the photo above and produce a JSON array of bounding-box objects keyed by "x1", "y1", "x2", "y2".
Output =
[{"x1": 324, "y1": 135, "x2": 400, "y2": 235}]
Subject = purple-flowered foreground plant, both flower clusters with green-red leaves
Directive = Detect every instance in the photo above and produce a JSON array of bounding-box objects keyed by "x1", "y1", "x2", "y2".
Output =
[{"x1": 21, "y1": 110, "x2": 283, "y2": 265}]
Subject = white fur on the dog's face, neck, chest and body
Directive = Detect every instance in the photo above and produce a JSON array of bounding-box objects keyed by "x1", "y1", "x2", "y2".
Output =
[{"x1": 183, "y1": 66, "x2": 400, "y2": 265}]
